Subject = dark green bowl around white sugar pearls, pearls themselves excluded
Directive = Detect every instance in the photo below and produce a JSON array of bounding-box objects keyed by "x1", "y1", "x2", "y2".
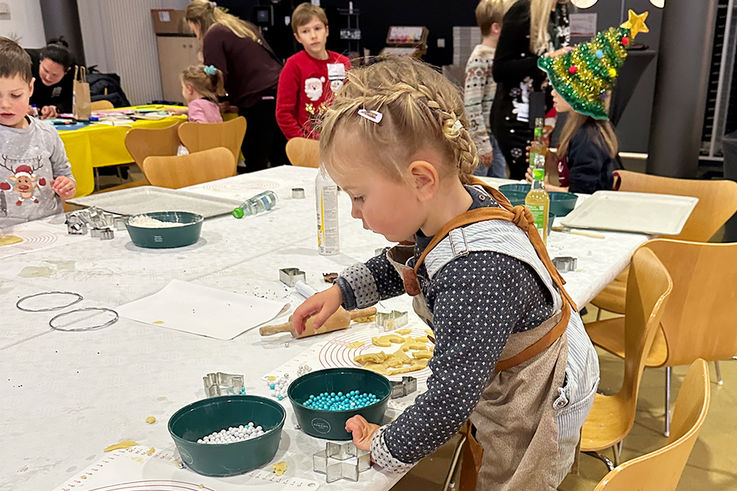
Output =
[{"x1": 168, "y1": 396, "x2": 286, "y2": 477}]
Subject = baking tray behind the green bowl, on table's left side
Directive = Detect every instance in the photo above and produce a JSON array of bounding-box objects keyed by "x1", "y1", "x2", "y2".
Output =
[{"x1": 69, "y1": 186, "x2": 241, "y2": 218}]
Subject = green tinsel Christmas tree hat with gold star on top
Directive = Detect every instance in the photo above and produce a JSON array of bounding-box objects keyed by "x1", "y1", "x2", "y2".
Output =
[{"x1": 537, "y1": 10, "x2": 648, "y2": 119}]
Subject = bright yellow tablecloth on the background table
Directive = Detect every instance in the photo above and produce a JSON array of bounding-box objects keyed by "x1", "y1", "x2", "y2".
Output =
[{"x1": 59, "y1": 106, "x2": 187, "y2": 196}]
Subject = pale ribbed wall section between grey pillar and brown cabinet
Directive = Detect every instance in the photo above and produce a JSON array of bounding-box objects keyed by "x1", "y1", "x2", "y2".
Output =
[{"x1": 75, "y1": 0, "x2": 189, "y2": 104}]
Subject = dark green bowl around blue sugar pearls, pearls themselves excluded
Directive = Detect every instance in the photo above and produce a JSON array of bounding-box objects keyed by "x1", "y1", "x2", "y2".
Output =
[{"x1": 287, "y1": 368, "x2": 392, "y2": 440}]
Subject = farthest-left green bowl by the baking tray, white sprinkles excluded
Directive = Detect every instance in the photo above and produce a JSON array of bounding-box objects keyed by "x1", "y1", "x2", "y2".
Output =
[{"x1": 125, "y1": 211, "x2": 204, "y2": 249}]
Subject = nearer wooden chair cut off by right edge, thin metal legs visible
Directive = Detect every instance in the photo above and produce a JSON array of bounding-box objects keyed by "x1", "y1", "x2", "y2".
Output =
[{"x1": 586, "y1": 239, "x2": 737, "y2": 436}]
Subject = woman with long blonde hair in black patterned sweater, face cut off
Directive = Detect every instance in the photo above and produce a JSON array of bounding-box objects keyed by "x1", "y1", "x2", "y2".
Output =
[{"x1": 491, "y1": 0, "x2": 570, "y2": 179}]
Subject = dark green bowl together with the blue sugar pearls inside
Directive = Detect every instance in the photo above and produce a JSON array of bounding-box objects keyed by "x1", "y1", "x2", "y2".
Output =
[{"x1": 287, "y1": 368, "x2": 392, "y2": 440}]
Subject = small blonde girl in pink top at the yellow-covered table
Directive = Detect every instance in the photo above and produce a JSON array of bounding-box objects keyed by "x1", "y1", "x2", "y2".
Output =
[{"x1": 180, "y1": 65, "x2": 225, "y2": 123}]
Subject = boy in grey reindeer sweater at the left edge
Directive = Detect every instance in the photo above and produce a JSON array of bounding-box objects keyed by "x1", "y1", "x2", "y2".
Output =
[{"x1": 0, "y1": 37, "x2": 77, "y2": 227}]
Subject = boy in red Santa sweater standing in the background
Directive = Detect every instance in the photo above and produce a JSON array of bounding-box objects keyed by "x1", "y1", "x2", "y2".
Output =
[{"x1": 276, "y1": 2, "x2": 351, "y2": 139}]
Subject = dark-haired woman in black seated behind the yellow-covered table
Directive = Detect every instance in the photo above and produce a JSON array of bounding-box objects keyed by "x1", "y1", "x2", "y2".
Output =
[{"x1": 26, "y1": 38, "x2": 74, "y2": 119}]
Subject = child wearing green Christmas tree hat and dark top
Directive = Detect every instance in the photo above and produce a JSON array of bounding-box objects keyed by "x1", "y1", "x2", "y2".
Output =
[{"x1": 527, "y1": 10, "x2": 648, "y2": 193}]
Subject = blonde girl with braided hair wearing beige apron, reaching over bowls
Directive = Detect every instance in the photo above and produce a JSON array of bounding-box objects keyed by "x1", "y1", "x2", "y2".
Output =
[{"x1": 293, "y1": 57, "x2": 598, "y2": 490}]
